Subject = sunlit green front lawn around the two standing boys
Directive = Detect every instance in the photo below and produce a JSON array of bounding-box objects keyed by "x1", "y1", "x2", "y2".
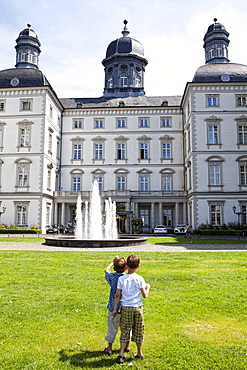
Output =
[{"x1": 0, "y1": 251, "x2": 247, "y2": 370}]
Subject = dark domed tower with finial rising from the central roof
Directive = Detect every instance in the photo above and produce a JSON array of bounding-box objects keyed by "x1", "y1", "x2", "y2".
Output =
[{"x1": 102, "y1": 21, "x2": 148, "y2": 98}]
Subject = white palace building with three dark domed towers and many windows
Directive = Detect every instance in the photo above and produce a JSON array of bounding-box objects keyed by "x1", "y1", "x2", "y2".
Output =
[{"x1": 0, "y1": 19, "x2": 247, "y2": 233}]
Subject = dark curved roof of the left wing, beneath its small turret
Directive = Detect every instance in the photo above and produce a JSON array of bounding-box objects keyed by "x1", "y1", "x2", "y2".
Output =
[{"x1": 0, "y1": 68, "x2": 49, "y2": 88}]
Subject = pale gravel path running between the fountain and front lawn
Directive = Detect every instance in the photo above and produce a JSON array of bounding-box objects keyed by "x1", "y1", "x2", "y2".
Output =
[{"x1": 0, "y1": 241, "x2": 247, "y2": 252}]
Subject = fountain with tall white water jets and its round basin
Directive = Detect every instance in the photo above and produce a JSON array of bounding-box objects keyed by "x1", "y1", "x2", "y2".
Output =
[{"x1": 45, "y1": 181, "x2": 147, "y2": 248}]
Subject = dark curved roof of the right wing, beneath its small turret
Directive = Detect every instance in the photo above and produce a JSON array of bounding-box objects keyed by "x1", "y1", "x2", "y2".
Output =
[{"x1": 192, "y1": 63, "x2": 247, "y2": 82}]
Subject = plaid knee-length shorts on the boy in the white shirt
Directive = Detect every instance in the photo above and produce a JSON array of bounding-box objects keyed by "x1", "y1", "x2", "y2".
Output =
[{"x1": 120, "y1": 307, "x2": 144, "y2": 343}]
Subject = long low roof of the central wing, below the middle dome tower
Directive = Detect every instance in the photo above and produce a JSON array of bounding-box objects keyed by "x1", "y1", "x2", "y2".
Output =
[{"x1": 60, "y1": 95, "x2": 182, "y2": 108}]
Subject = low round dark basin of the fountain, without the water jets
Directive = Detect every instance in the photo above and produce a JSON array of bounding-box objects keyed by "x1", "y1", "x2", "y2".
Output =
[{"x1": 45, "y1": 236, "x2": 147, "y2": 248}]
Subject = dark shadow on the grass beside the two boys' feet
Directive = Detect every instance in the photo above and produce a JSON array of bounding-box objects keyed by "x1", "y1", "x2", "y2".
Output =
[{"x1": 59, "y1": 349, "x2": 123, "y2": 369}]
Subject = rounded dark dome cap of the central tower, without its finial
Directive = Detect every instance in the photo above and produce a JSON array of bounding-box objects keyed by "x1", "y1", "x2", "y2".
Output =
[{"x1": 106, "y1": 37, "x2": 144, "y2": 59}]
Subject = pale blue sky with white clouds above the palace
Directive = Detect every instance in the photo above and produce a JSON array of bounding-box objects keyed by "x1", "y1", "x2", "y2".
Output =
[{"x1": 0, "y1": 0, "x2": 247, "y2": 98}]
